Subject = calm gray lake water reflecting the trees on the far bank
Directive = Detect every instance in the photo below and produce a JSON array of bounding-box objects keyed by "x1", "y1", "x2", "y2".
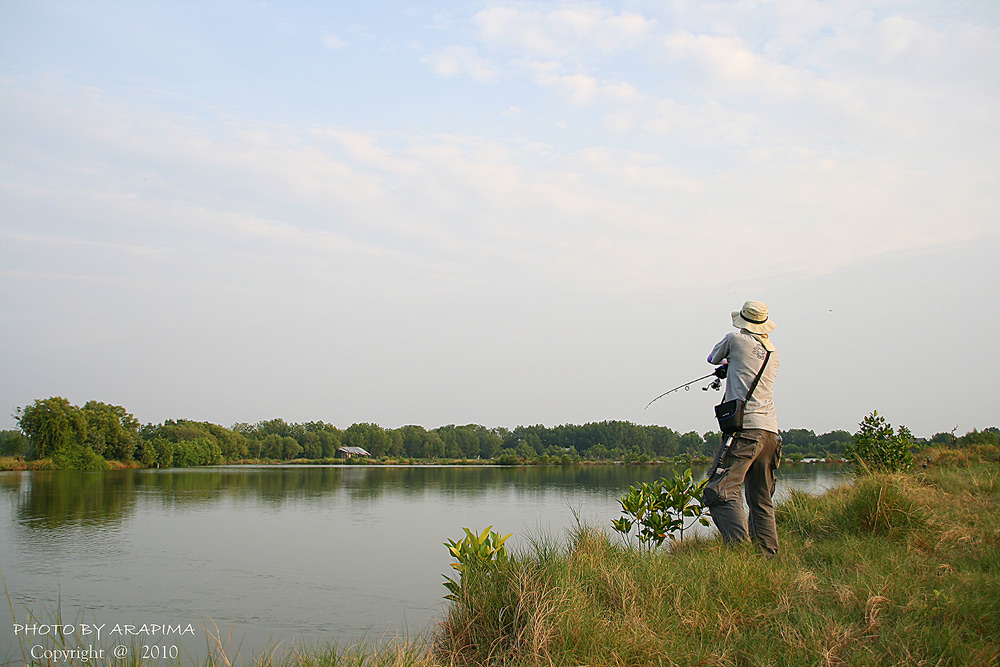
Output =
[{"x1": 0, "y1": 464, "x2": 844, "y2": 664}]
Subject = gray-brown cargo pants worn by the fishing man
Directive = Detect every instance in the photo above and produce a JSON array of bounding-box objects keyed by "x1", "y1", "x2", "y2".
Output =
[{"x1": 703, "y1": 429, "x2": 781, "y2": 555}]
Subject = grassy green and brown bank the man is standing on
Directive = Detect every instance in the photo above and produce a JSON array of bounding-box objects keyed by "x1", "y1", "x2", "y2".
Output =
[{"x1": 9, "y1": 444, "x2": 1000, "y2": 667}]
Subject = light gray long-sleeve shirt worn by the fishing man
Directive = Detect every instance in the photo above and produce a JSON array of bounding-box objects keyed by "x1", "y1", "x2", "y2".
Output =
[{"x1": 708, "y1": 329, "x2": 780, "y2": 433}]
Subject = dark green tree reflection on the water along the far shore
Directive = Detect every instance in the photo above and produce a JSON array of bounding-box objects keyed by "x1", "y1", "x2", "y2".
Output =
[{"x1": 0, "y1": 464, "x2": 841, "y2": 530}]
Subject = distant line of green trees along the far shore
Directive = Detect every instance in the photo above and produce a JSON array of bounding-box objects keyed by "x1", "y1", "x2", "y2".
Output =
[{"x1": 0, "y1": 397, "x2": 1000, "y2": 469}]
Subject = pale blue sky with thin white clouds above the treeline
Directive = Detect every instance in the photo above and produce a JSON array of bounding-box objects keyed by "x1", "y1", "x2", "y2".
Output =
[{"x1": 0, "y1": 0, "x2": 1000, "y2": 436}]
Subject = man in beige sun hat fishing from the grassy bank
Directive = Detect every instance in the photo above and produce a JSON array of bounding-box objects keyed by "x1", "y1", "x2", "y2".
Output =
[{"x1": 703, "y1": 301, "x2": 781, "y2": 555}]
